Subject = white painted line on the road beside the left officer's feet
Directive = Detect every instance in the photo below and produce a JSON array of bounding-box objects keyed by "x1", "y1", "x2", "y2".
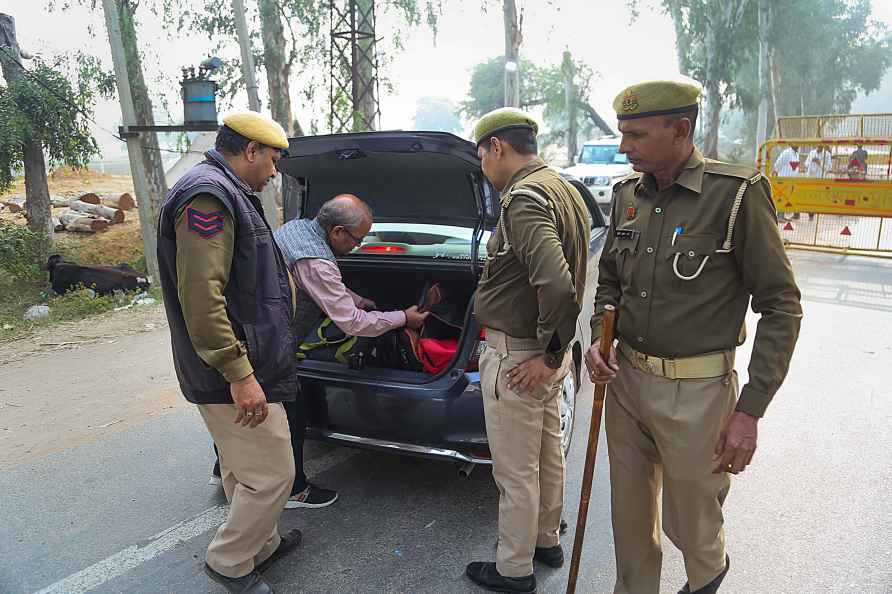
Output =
[{"x1": 35, "y1": 448, "x2": 358, "y2": 594}]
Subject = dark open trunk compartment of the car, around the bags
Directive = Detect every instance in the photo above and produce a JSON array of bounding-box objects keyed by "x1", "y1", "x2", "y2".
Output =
[{"x1": 300, "y1": 255, "x2": 479, "y2": 383}]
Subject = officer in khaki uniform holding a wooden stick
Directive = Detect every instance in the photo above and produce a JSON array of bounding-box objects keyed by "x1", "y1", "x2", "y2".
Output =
[{"x1": 586, "y1": 81, "x2": 802, "y2": 594}]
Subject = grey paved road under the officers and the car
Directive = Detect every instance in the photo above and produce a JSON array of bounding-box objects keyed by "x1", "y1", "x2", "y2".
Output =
[{"x1": 0, "y1": 252, "x2": 892, "y2": 594}]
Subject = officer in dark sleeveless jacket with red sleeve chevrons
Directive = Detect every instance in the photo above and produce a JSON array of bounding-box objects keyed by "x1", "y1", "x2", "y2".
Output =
[{"x1": 158, "y1": 112, "x2": 300, "y2": 594}]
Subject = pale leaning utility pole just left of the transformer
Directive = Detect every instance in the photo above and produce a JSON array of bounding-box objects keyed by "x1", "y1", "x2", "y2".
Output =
[{"x1": 102, "y1": 0, "x2": 161, "y2": 282}]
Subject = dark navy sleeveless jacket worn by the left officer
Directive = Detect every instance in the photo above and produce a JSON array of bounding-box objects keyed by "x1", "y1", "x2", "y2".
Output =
[{"x1": 158, "y1": 150, "x2": 297, "y2": 404}]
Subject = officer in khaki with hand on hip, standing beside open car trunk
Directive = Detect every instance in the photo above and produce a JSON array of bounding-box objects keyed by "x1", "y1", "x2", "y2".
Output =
[{"x1": 467, "y1": 108, "x2": 590, "y2": 592}]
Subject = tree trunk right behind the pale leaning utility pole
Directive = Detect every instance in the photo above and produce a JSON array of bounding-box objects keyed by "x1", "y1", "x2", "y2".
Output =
[{"x1": 115, "y1": 0, "x2": 167, "y2": 217}]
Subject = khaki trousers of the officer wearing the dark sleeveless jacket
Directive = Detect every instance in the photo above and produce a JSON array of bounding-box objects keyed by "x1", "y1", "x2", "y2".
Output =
[{"x1": 198, "y1": 402, "x2": 294, "y2": 577}]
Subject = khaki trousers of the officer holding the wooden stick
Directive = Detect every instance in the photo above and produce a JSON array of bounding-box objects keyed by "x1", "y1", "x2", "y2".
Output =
[{"x1": 605, "y1": 354, "x2": 737, "y2": 594}]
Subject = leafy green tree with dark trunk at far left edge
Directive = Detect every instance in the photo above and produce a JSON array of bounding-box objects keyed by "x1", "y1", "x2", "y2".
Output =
[{"x1": 0, "y1": 15, "x2": 112, "y2": 242}]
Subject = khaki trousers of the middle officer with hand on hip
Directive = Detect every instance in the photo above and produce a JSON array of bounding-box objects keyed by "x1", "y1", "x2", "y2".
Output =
[{"x1": 480, "y1": 329, "x2": 570, "y2": 577}]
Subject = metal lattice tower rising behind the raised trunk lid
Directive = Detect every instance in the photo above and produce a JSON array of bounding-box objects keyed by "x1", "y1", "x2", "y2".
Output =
[{"x1": 328, "y1": 0, "x2": 381, "y2": 132}]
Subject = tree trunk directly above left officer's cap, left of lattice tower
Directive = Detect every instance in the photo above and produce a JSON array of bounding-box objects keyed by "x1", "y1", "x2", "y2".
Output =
[{"x1": 260, "y1": 0, "x2": 300, "y2": 137}]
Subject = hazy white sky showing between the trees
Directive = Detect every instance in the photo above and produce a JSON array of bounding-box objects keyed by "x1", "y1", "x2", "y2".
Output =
[{"x1": 0, "y1": 0, "x2": 892, "y2": 159}]
